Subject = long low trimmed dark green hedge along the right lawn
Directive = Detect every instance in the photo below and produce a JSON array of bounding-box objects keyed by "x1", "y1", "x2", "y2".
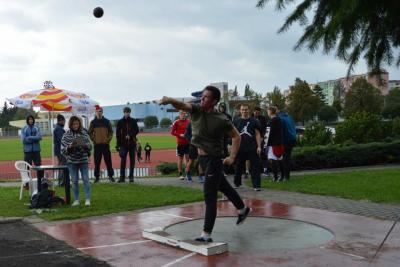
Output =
[{"x1": 292, "y1": 140, "x2": 400, "y2": 170}]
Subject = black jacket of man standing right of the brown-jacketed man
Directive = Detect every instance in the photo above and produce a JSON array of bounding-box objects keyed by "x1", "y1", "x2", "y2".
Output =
[{"x1": 115, "y1": 117, "x2": 139, "y2": 148}]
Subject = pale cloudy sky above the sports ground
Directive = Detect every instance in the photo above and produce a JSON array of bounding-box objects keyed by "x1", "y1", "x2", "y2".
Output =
[{"x1": 0, "y1": 0, "x2": 400, "y2": 108}]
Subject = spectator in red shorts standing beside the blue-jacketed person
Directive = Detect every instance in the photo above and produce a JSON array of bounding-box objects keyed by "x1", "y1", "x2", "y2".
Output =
[{"x1": 265, "y1": 106, "x2": 284, "y2": 182}]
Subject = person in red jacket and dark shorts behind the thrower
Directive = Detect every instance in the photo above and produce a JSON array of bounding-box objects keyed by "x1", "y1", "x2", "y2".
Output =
[{"x1": 171, "y1": 110, "x2": 190, "y2": 180}]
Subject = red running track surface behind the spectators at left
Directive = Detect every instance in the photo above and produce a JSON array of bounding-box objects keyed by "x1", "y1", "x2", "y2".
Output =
[{"x1": 0, "y1": 149, "x2": 176, "y2": 179}]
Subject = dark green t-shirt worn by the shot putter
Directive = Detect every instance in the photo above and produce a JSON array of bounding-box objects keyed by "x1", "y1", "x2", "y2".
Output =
[{"x1": 190, "y1": 105, "x2": 233, "y2": 156}]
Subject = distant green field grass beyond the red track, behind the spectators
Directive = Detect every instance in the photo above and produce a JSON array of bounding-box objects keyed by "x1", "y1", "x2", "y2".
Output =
[{"x1": 0, "y1": 134, "x2": 176, "y2": 161}]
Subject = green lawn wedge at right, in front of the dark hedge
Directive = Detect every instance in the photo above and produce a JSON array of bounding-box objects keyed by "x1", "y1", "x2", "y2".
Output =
[{"x1": 262, "y1": 169, "x2": 400, "y2": 204}]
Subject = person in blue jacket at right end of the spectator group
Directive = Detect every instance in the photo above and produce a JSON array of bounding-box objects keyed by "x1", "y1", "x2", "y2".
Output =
[{"x1": 277, "y1": 110, "x2": 296, "y2": 180}]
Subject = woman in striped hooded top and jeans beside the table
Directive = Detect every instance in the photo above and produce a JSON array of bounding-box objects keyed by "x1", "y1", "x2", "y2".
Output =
[{"x1": 61, "y1": 116, "x2": 91, "y2": 206}]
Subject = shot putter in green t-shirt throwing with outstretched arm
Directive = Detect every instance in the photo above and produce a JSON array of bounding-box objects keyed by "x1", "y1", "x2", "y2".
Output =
[{"x1": 160, "y1": 86, "x2": 251, "y2": 242}]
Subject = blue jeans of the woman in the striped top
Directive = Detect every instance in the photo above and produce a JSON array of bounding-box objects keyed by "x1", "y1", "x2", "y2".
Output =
[{"x1": 68, "y1": 163, "x2": 90, "y2": 200}]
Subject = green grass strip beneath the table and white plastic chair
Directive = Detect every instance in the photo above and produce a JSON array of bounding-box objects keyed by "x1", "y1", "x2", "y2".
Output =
[{"x1": 0, "y1": 184, "x2": 203, "y2": 221}]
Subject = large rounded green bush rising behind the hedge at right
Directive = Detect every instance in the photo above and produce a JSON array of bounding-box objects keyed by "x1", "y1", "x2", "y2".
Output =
[{"x1": 335, "y1": 112, "x2": 383, "y2": 144}]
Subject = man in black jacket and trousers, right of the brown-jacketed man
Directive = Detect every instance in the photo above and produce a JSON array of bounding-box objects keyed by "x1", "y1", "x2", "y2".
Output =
[{"x1": 116, "y1": 107, "x2": 139, "y2": 183}]
